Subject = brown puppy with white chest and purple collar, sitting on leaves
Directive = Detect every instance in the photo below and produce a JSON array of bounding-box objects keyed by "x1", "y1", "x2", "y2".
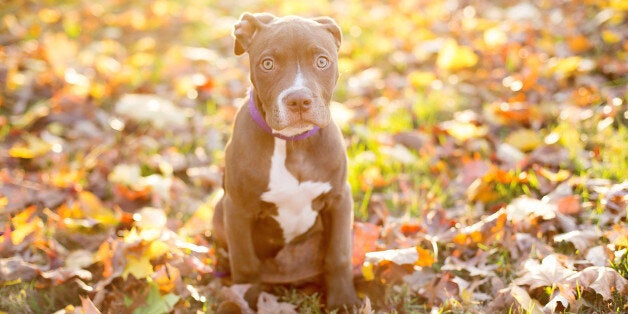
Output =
[{"x1": 214, "y1": 13, "x2": 359, "y2": 308}]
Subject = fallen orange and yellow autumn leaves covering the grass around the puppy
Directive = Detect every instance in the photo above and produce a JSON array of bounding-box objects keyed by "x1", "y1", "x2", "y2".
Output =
[{"x1": 0, "y1": 0, "x2": 628, "y2": 313}]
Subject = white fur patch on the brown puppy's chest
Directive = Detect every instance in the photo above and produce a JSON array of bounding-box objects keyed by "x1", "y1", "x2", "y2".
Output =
[{"x1": 262, "y1": 138, "x2": 331, "y2": 243}]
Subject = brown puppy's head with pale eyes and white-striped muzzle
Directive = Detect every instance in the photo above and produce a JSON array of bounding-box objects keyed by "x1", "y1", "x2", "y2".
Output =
[{"x1": 233, "y1": 13, "x2": 342, "y2": 136}]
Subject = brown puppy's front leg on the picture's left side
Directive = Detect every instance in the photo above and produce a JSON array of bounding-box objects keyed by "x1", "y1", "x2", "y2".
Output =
[{"x1": 223, "y1": 195, "x2": 260, "y2": 284}]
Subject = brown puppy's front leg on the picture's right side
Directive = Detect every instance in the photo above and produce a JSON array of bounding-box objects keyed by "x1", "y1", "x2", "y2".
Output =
[{"x1": 323, "y1": 185, "x2": 360, "y2": 309}]
